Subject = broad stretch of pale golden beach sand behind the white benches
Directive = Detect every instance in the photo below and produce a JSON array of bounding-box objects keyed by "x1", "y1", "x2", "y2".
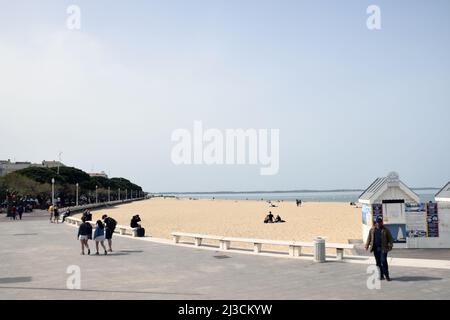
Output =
[{"x1": 84, "y1": 198, "x2": 361, "y2": 250}]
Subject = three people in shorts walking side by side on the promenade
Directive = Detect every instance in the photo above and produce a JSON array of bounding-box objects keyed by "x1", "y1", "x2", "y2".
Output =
[{"x1": 77, "y1": 212, "x2": 117, "y2": 255}]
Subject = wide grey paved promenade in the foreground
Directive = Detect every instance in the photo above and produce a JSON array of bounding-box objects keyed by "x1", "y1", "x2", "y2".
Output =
[{"x1": 0, "y1": 218, "x2": 450, "y2": 299}]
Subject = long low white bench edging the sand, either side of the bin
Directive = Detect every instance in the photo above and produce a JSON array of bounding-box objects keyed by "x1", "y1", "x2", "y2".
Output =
[{"x1": 172, "y1": 232, "x2": 354, "y2": 260}]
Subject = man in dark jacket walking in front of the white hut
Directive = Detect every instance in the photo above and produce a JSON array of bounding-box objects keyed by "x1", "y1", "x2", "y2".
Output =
[{"x1": 366, "y1": 217, "x2": 394, "y2": 281}]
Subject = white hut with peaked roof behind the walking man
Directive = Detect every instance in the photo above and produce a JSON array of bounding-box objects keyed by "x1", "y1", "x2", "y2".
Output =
[{"x1": 359, "y1": 172, "x2": 418, "y2": 248}]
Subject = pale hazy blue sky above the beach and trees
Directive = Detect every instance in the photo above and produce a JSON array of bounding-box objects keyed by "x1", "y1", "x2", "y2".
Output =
[{"x1": 0, "y1": 0, "x2": 450, "y2": 192}]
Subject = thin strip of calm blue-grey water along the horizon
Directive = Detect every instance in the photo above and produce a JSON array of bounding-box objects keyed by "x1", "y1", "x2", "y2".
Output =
[{"x1": 165, "y1": 190, "x2": 438, "y2": 202}]
